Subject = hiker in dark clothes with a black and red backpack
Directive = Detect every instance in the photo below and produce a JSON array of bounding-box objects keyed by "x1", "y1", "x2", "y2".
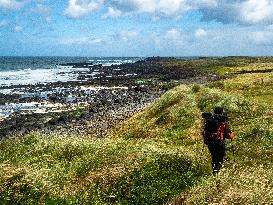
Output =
[{"x1": 202, "y1": 107, "x2": 234, "y2": 174}]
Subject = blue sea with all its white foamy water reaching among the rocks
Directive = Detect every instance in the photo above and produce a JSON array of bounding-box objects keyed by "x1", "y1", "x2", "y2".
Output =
[{"x1": 0, "y1": 56, "x2": 142, "y2": 122}]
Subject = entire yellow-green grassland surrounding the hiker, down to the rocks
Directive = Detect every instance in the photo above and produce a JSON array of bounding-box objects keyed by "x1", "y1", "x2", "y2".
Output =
[{"x1": 0, "y1": 59, "x2": 273, "y2": 204}]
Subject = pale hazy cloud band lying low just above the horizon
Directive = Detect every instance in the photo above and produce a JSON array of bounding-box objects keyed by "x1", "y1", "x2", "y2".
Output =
[{"x1": 54, "y1": 25, "x2": 273, "y2": 56}]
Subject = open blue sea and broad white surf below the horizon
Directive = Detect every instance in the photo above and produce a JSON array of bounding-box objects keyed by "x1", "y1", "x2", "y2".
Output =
[{"x1": 0, "y1": 56, "x2": 141, "y2": 87}]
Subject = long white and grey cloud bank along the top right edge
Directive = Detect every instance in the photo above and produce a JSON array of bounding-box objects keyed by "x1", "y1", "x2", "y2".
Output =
[{"x1": 103, "y1": 0, "x2": 273, "y2": 24}]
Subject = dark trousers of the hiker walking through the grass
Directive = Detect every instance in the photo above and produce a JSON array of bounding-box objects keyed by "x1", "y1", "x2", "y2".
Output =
[{"x1": 208, "y1": 140, "x2": 225, "y2": 174}]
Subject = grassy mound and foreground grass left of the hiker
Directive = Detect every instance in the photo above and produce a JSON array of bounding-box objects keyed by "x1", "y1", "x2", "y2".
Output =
[{"x1": 0, "y1": 86, "x2": 209, "y2": 204}]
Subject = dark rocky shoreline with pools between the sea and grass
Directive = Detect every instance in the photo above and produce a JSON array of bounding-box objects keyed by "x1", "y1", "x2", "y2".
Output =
[{"x1": 0, "y1": 58, "x2": 214, "y2": 139}]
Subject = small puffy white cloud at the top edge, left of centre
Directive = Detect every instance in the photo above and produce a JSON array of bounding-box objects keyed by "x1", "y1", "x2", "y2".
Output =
[{"x1": 64, "y1": 0, "x2": 104, "y2": 18}]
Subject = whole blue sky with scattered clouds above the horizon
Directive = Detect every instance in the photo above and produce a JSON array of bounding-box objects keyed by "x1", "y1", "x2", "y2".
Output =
[{"x1": 0, "y1": 0, "x2": 273, "y2": 57}]
